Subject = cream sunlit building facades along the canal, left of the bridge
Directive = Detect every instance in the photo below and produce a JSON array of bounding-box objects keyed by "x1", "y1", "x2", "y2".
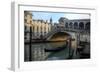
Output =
[{"x1": 24, "y1": 11, "x2": 52, "y2": 40}]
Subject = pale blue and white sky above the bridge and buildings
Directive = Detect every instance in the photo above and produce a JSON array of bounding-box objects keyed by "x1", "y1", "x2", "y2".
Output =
[{"x1": 32, "y1": 11, "x2": 90, "y2": 23}]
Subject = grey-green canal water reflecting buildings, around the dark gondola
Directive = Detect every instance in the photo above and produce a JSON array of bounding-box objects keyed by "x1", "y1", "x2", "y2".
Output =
[{"x1": 24, "y1": 42, "x2": 79, "y2": 62}]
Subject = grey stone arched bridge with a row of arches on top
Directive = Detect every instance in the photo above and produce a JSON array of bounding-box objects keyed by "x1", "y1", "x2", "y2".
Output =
[{"x1": 44, "y1": 19, "x2": 90, "y2": 48}]
